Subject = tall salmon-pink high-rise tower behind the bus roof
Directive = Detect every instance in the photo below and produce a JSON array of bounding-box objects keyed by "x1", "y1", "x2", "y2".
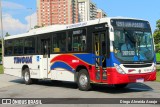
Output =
[{"x1": 37, "y1": 0, "x2": 78, "y2": 26}]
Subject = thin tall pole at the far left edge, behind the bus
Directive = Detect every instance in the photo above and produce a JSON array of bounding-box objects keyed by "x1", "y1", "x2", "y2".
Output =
[{"x1": 0, "y1": 0, "x2": 4, "y2": 64}]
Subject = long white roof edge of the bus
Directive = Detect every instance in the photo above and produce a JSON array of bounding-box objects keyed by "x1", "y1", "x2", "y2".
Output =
[{"x1": 4, "y1": 17, "x2": 148, "y2": 40}]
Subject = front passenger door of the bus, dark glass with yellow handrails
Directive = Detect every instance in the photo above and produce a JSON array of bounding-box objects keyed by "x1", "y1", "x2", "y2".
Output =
[{"x1": 93, "y1": 32, "x2": 107, "y2": 82}]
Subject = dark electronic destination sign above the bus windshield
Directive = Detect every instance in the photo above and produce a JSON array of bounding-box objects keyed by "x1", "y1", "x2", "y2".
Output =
[{"x1": 111, "y1": 19, "x2": 150, "y2": 28}]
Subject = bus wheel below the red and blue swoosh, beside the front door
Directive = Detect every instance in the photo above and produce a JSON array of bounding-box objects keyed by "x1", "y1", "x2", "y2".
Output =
[{"x1": 77, "y1": 69, "x2": 91, "y2": 91}]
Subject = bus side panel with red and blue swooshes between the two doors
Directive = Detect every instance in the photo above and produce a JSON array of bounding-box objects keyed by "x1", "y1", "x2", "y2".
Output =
[{"x1": 50, "y1": 53, "x2": 93, "y2": 81}]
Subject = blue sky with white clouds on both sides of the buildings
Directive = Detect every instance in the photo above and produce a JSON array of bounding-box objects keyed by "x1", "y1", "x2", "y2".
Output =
[{"x1": 0, "y1": 0, "x2": 160, "y2": 35}]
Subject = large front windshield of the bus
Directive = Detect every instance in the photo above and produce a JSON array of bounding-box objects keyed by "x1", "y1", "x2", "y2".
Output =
[{"x1": 113, "y1": 29, "x2": 154, "y2": 63}]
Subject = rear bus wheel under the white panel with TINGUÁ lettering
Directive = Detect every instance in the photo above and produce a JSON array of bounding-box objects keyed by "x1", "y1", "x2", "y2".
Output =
[{"x1": 23, "y1": 68, "x2": 32, "y2": 85}]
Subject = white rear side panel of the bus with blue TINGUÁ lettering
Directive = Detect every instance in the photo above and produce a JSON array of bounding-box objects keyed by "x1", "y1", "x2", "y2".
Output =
[{"x1": 4, "y1": 56, "x2": 40, "y2": 78}]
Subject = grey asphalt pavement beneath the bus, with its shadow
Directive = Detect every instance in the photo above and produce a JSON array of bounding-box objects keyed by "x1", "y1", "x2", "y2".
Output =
[{"x1": 0, "y1": 74, "x2": 160, "y2": 107}]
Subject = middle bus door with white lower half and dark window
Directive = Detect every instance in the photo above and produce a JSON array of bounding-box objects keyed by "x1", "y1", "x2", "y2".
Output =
[{"x1": 41, "y1": 38, "x2": 50, "y2": 78}]
